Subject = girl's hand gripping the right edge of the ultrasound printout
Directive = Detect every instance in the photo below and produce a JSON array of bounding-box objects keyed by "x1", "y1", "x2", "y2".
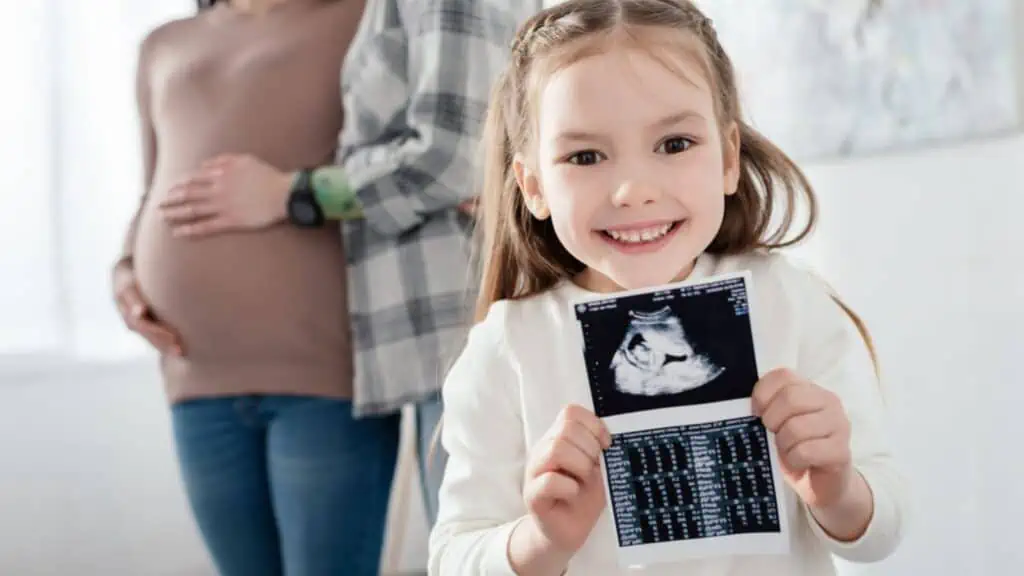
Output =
[{"x1": 754, "y1": 369, "x2": 856, "y2": 508}]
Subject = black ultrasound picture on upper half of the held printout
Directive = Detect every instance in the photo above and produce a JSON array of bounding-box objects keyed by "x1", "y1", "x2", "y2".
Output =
[{"x1": 577, "y1": 278, "x2": 758, "y2": 417}]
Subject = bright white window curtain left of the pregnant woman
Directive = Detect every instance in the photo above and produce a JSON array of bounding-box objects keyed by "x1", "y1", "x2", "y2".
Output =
[{"x1": 0, "y1": 0, "x2": 195, "y2": 360}]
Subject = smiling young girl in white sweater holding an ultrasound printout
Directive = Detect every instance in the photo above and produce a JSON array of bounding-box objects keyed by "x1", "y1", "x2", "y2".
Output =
[{"x1": 430, "y1": 0, "x2": 904, "y2": 576}]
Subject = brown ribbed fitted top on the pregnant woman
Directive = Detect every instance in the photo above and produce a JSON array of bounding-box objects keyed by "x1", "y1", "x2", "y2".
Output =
[{"x1": 125, "y1": 0, "x2": 364, "y2": 402}]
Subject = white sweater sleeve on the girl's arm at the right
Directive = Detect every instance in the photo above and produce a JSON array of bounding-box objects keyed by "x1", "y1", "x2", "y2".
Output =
[{"x1": 787, "y1": 260, "x2": 906, "y2": 563}]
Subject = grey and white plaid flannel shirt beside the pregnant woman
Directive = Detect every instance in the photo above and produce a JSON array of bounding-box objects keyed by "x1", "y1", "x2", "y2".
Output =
[{"x1": 338, "y1": 0, "x2": 540, "y2": 415}]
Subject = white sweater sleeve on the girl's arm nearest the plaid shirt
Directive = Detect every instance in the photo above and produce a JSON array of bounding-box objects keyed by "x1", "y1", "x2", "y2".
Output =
[{"x1": 429, "y1": 302, "x2": 527, "y2": 576}]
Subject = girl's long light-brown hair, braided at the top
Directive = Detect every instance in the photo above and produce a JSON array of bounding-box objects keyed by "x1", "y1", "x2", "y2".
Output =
[{"x1": 475, "y1": 0, "x2": 877, "y2": 368}]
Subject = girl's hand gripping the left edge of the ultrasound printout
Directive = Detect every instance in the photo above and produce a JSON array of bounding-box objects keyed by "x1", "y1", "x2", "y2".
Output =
[{"x1": 524, "y1": 405, "x2": 611, "y2": 554}]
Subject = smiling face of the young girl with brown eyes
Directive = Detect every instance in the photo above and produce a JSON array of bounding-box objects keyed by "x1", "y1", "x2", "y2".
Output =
[{"x1": 515, "y1": 38, "x2": 739, "y2": 292}]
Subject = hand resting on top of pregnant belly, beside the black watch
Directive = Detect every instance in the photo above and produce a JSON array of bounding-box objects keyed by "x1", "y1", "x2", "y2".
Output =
[{"x1": 159, "y1": 155, "x2": 292, "y2": 237}]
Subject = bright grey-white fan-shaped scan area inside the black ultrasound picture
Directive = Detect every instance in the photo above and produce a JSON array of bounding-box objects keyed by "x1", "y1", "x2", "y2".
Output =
[{"x1": 610, "y1": 305, "x2": 725, "y2": 396}]
